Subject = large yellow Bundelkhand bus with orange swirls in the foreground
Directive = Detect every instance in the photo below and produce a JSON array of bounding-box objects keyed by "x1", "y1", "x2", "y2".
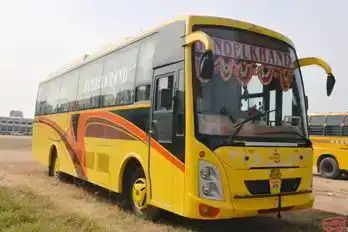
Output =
[{"x1": 32, "y1": 15, "x2": 335, "y2": 220}]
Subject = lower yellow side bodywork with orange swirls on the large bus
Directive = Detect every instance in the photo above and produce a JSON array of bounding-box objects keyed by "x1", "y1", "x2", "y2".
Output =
[{"x1": 33, "y1": 107, "x2": 184, "y2": 212}]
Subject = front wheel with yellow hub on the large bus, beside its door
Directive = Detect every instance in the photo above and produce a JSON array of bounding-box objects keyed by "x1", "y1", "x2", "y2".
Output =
[{"x1": 126, "y1": 167, "x2": 160, "y2": 220}]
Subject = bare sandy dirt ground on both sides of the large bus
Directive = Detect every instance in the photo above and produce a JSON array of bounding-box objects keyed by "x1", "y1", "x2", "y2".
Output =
[{"x1": 0, "y1": 136, "x2": 348, "y2": 230}]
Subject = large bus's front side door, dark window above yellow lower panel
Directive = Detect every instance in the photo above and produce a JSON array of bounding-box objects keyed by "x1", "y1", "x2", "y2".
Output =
[{"x1": 149, "y1": 63, "x2": 184, "y2": 208}]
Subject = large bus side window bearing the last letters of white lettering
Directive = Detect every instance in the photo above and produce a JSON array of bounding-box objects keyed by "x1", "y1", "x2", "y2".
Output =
[{"x1": 101, "y1": 46, "x2": 139, "y2": 106}]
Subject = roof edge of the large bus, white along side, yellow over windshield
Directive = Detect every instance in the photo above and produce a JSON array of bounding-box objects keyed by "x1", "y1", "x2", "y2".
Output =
[{"x1": 40, "y1": 15, "x2": 294, "y2": 84}]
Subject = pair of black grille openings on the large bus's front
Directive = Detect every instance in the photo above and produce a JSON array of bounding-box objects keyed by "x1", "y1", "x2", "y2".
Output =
[{"x1": 244, "y1": 178, "x2": 301, "y2": 195}]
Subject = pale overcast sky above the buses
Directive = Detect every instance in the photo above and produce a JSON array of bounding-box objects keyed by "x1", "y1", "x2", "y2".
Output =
[{"x1": 0, "y1": 0, "x2": 348, "y2": 117}]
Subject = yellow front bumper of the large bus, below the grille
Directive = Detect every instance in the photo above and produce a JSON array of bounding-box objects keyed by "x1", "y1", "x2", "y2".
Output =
[{"x1": 185, "y1": 191, "x2": 314, "y2": 220}]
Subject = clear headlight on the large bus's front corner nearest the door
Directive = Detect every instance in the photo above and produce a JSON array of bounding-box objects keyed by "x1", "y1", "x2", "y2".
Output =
[{"x1": 199, "y1": 160, "x2": 224, "y2": 200}]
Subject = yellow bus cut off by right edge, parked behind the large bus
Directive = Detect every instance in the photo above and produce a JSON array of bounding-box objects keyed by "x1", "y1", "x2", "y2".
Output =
[{"x1": 308, "y1": 112, "x2": 348, "y2": 179}]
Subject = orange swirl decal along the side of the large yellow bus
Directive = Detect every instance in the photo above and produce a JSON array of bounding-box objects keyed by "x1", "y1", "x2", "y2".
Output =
[{"x1": 36, "y1": 111, "x2": 185, "y2": 176}]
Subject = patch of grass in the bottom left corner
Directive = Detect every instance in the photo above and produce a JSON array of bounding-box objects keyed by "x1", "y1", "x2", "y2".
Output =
[{"x1": 0, "y1": 187, "x2": 104, "y2": 232}]
